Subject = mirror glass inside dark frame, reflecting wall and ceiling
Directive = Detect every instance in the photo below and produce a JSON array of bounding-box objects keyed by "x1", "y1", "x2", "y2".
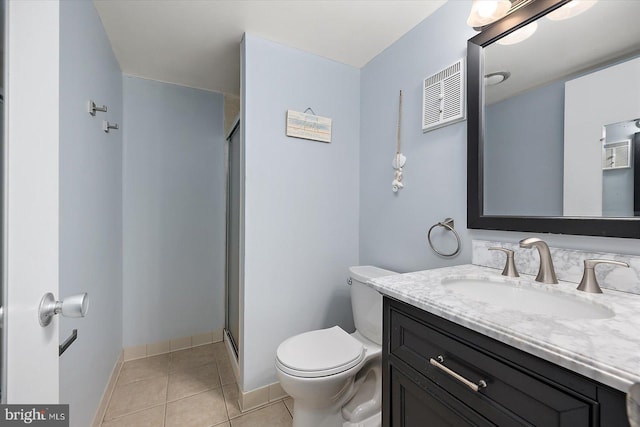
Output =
[{"x1": 483, "y1": 0, "x2": 640, "y2": 217}]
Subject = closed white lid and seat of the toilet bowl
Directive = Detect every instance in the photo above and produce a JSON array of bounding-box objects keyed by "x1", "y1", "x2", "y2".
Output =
[{"x1": 276, "y1": 326, "x2": 365, "y2": 378}]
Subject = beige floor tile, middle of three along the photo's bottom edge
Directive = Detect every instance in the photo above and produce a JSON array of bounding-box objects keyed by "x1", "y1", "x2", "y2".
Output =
[{"x1": 165, "y1": 388, "x2": 228, "y2": 427}]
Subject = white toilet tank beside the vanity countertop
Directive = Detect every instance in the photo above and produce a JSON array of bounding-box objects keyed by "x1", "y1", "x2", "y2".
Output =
[{"x1": 349, "y1": 265, "x2": 398, "y2": 345}]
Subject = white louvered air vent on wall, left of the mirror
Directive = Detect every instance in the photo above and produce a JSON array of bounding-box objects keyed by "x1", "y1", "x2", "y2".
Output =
[{"x1": 422, "y1": 59, "x2": 465, "y2": 132}]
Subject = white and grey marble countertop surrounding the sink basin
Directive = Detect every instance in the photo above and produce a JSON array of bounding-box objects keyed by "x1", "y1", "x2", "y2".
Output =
[{"x1": 368, "y1": 265, "x2": 640, "y2": 393}]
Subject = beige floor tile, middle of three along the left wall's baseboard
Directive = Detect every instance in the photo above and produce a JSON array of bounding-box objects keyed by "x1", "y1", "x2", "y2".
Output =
[{"x1": 105, "y1": 376, "x2": 168, "y2": 420}]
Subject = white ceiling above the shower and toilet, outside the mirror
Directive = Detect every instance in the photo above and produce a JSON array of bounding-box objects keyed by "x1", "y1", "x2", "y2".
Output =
[{"x1": 94, "y1": 0, "x2": 446, "y2": 95}]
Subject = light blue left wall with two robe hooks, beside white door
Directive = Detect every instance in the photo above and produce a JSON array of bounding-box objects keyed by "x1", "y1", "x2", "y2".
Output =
[{"x1": 58, "y1": 1, "x2": 122, "y2": 427}]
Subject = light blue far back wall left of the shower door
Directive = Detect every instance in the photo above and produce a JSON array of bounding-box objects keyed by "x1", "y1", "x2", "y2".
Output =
[{"x1": 122, "y1": 75, "x2": 225, "y2": 347}]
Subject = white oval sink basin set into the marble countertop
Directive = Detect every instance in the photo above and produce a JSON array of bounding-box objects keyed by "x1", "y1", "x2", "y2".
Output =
[{"x1": 442, "y1": 278, "x2": 615, "y2": 319}]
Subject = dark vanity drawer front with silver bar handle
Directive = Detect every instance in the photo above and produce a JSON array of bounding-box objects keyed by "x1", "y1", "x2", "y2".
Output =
[{"x1": 385, "y1": 301, "x2": 599, "y2": 427}]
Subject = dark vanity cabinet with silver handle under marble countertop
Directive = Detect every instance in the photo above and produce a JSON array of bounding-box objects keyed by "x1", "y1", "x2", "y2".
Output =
[{"x1": 382, "y1": 297, "x2": 629, "y2": 427}]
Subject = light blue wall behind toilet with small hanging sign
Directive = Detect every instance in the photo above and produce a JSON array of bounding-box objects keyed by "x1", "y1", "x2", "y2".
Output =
[{"x1": 240, "y1": 34, "x2": 360, "y2": 391}]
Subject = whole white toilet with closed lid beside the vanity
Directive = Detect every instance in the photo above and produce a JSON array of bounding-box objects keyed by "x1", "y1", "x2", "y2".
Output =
[{"x1": 276, "y1": 266, "x2": 397, "y2": 427}]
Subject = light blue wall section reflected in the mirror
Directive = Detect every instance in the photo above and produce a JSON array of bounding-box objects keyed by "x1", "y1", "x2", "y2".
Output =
[{"x1": 484, "y1": 80, "x2": 564, "y2": 216}]
